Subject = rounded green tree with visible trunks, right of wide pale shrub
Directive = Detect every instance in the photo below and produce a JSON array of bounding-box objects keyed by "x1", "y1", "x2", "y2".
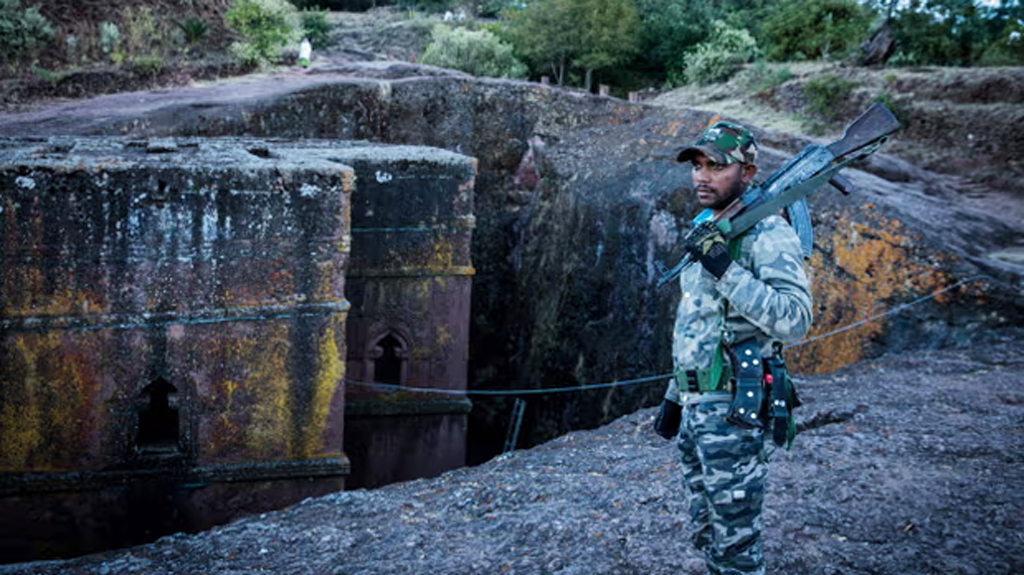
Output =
[{"x1": 507, "y1": 0, "x2": 640, "y2": 89}]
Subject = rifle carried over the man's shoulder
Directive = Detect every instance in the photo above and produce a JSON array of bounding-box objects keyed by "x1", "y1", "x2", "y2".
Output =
[{"x1": 657, "y1": 103, "x2": 899, "y2": 285}]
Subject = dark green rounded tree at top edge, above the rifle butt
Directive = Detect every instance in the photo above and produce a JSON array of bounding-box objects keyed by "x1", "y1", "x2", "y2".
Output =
[{"x1": 762, "y1": 0, "x2": 874, "y2": 60}]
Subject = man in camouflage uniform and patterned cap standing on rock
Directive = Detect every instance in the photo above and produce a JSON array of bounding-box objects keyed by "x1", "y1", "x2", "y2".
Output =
[{"x1": 655, "y1": 122, "x2": 811, "y2": 575}]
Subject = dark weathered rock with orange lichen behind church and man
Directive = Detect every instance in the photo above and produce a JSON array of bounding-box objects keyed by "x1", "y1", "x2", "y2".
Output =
[{"x1": 5, "y1": 60, "x2": 1021, "y2": 461}]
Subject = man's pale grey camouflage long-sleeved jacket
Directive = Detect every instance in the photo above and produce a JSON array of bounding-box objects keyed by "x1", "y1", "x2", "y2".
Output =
[{"x1": 665, "y1": 211, "x2": 811, "y2": 403}]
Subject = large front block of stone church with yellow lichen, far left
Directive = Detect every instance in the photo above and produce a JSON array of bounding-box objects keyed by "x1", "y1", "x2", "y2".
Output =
[{"x1": 0, "y1": 138, "x2": 353, "y2": 560}]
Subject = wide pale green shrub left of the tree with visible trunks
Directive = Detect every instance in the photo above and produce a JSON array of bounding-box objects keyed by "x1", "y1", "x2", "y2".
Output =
[{"x1": 419, "y1": 25, "x2": 527, "y2": 78}]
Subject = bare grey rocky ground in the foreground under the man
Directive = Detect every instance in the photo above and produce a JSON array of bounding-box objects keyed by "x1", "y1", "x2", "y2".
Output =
[{"x1": 0, "y1": 329, "x2": 1024, "y2": 575}]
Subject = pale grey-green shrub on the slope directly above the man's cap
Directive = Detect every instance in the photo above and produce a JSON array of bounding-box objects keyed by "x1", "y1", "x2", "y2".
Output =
[{"x1": 686, "y1": 20, "x2": 760, "y2": 85}]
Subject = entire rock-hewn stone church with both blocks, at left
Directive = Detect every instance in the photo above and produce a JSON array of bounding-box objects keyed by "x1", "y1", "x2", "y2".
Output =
[{"x1": 0, "y1": 133, "x2": 477, "y2": 561}]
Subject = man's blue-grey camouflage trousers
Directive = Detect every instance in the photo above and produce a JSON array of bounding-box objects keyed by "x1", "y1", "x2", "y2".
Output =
[{"x1": 679, "y1": 402, "x2": 768, "y2": 575}]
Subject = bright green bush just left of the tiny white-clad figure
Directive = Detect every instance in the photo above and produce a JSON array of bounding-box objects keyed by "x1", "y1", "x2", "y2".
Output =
[{"x1": 224, "y1": 0, "x2": 302, "y2": 67}]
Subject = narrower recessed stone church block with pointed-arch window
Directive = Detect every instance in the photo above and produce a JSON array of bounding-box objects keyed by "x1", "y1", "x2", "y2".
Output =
[{"x1": 341, "y1": 142, "x2": 476, "y2": 487}]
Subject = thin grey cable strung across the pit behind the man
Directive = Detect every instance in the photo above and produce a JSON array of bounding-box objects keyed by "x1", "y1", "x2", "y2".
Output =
[{"x1": 345, "y1": 274, "x2": 991, "y2": 396}]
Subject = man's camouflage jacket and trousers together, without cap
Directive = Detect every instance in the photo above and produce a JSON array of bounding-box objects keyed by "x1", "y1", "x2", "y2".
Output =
[{"x1": 665, "y1": 121, "x2": 811, "y2": 575}]
